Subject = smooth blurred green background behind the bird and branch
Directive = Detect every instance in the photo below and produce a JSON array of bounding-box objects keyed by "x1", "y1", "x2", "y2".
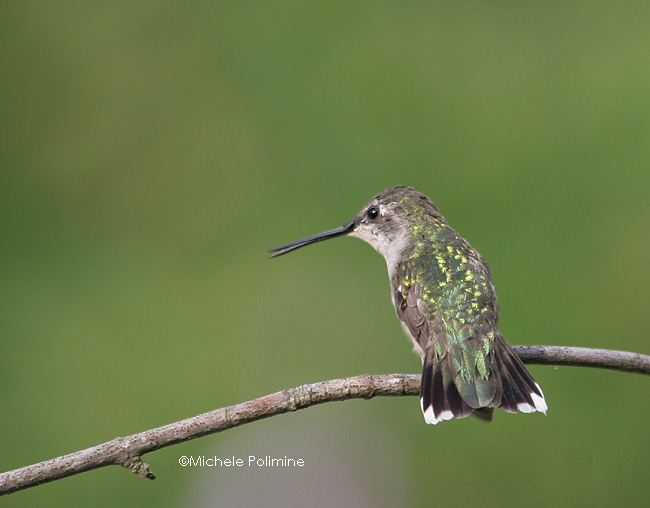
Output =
[{"x1": 0, "y1": 1, "x2": 650, "y2": 507}]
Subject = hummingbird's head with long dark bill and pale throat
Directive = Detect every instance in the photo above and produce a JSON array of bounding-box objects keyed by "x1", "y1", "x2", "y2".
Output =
[{"x1": 270, "y1": 186, "x2": 440, "y2": 269}]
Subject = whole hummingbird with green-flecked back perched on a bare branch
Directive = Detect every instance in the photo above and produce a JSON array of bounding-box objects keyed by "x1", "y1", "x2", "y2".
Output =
[{"x1": 269, "y1": 186, "x2": 548, "y2": 425}]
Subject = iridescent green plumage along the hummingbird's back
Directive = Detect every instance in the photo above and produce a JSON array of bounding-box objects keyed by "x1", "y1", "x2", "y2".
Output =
[{"x1": 398, "y1": 220, "x2": 499, "y2": 408}]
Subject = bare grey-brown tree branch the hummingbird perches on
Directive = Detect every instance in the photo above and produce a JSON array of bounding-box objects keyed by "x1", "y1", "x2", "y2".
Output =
[{"x1": 0, "y1": 346, "x2": 650, "y2": 495}]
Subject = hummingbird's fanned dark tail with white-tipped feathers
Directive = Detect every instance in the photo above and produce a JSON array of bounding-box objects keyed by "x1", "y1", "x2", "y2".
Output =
[{"x1": 420, "y1": 332, "x2": 548, "y2": 425}]
